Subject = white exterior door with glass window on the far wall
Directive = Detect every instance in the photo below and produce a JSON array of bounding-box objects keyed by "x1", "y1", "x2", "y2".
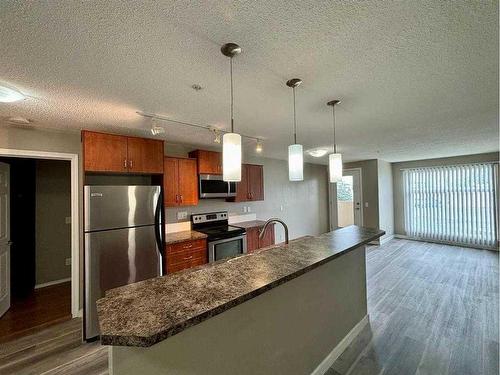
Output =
[{"x1": 330, "y1": 169, "x2": 363, "y2": 230}]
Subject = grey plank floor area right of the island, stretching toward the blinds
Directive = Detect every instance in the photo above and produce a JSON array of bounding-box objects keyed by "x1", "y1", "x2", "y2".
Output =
[{"x1": 327, "y1": 240, "x2": 499, "y2": 375}]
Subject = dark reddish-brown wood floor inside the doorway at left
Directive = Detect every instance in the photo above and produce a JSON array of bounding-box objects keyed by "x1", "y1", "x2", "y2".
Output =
[{"x1": 0, "y1": 282, "x2": 71, "y2": 343}]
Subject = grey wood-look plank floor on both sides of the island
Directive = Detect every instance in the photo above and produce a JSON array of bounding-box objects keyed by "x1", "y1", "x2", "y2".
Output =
[{"x1": 0, "y1": 240, "x2": 499, "y2": 375}]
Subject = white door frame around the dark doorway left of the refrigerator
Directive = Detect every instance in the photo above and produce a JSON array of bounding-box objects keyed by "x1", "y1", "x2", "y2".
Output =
[{"x1": 0, "y1": 148, "x2": 82, "y2": 318}]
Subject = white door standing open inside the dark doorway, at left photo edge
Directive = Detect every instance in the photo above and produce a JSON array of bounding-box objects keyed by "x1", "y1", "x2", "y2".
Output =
[{"x1": 0, "y1": 163, "x2": 11, "y2": 316}]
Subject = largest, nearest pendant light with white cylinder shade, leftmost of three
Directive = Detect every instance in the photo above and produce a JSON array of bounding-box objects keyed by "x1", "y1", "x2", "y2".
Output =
[{"x1": 221, "y1": 43, "x2": 241, "y2": 182}]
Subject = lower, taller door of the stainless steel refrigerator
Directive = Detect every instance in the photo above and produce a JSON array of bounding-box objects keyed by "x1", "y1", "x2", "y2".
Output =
[{"x1": 85, "y1": 226, "x2": 161, "y2": 339}]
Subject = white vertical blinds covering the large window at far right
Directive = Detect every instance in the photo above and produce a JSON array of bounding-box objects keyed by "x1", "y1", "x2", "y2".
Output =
[{"x1": 403, "y1": 163, "x2": 498, "y2": 247}]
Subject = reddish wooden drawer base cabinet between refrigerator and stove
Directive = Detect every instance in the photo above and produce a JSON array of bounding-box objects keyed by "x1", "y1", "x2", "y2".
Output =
[{"x1": 165, "y1": 239, "x2": 208, "y2": 273}]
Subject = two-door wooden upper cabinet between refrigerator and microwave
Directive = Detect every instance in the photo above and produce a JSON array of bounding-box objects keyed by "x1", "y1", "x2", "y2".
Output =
[{"x1": 163, "y1": 157, "x2": 198, "y2": 207}]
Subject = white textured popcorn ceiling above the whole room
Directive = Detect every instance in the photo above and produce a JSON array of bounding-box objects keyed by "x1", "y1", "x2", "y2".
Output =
[{"x1": 0, "y1": 0, "x2": 498, "y2": 162}]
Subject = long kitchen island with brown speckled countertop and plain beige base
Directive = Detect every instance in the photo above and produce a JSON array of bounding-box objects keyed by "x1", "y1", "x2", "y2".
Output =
[{"x1": 97, "y1": 226, "x2": 384, "y2": 375}]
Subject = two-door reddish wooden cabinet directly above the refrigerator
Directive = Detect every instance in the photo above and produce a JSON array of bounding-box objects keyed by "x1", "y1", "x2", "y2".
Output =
[{"x1": 82, "y1": 130, "x2": 163, "y2": 174}]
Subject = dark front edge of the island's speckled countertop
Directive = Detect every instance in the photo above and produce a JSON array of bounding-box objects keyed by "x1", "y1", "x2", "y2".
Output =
[{"x1": 101, "y1": 231, "x2": 385, "y2": 347}]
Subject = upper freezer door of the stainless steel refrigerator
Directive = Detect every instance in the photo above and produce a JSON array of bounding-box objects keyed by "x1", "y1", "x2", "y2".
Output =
[{"x1": 85, "y1": 186, "x2": 159, "y2": 232}]
